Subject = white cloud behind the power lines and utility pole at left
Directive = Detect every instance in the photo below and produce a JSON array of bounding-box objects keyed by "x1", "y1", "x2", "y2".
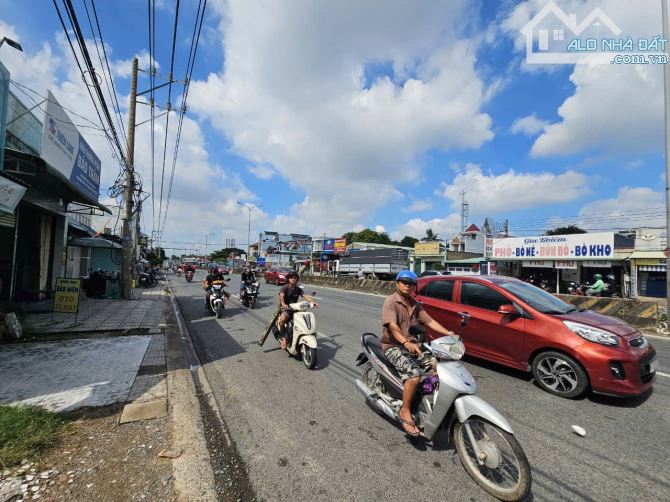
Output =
[{"x1": 0, "y1": 20, "x2": 269, "y2": 249}]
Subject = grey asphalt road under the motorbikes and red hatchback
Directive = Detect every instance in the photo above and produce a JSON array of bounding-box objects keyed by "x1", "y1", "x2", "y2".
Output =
[{"x1": 171, "y1": 271, "x2": 670, "y2": 501}]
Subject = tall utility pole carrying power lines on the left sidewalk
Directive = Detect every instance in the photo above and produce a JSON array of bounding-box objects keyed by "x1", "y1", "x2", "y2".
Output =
[{"x1": 121, "y1": 58, "x2": 139, "y2": 300}]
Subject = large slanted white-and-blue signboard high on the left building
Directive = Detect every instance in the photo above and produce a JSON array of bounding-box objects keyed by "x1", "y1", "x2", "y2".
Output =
[{"x1": 42, "y1": 91, "x2": 101, "y2": 201}]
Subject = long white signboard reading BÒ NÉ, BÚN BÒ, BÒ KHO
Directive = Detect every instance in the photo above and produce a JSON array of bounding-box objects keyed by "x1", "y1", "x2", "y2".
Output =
[{"x1": 493, "y1": 232, "x2": 614, "y2": 261}]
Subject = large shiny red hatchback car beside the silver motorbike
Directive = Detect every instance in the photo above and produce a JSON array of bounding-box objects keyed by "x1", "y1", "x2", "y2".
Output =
[{"x1": 416, "y1": 275, "x2": 657, "y2": 398}]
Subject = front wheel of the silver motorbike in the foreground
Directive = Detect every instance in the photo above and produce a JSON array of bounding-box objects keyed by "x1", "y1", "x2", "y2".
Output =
[{"x1": 454, "y1": 417, "x2": 532, "y2": 501}]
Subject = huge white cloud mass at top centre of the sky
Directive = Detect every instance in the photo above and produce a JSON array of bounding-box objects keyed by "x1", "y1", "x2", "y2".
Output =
[{"x1": 190, "y1": 1, "x2": 493, "y2": 232}]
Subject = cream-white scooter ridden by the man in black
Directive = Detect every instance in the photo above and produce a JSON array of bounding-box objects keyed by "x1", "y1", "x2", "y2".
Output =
[{"x1": 272, "y1": 301, "x2": 317, "y2": 370}]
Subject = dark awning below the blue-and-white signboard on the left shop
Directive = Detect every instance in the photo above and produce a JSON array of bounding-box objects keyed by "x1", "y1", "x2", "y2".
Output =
[{"x1": 3, "y1": 148, "x2": 112, "y2": 214}]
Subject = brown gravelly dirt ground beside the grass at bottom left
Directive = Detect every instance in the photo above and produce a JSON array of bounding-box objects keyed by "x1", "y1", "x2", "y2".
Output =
[{"x1": 0, "y1": 406, "x2": 176, "y2": 502}]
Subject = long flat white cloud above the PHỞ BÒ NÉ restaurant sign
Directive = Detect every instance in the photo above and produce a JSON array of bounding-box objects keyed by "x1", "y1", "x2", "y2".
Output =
[{"x1": 443, "y1": 164, "x2": 589, "y2": 214}]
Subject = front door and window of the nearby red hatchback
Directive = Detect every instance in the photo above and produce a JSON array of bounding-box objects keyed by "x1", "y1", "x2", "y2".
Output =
[{"x1": 458, "y1": 280, "x2": 525, "y2": 366}]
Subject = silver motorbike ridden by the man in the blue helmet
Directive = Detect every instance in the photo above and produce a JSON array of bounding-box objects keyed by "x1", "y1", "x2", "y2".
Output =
[{"x1": 355, "y1": 313, "x2": 532, "y2": 501}]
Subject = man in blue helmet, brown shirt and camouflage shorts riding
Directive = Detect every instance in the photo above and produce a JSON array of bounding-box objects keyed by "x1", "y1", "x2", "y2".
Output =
[{"x1": 381, "y1": 270, "x2": 458, "y2": 436}]
